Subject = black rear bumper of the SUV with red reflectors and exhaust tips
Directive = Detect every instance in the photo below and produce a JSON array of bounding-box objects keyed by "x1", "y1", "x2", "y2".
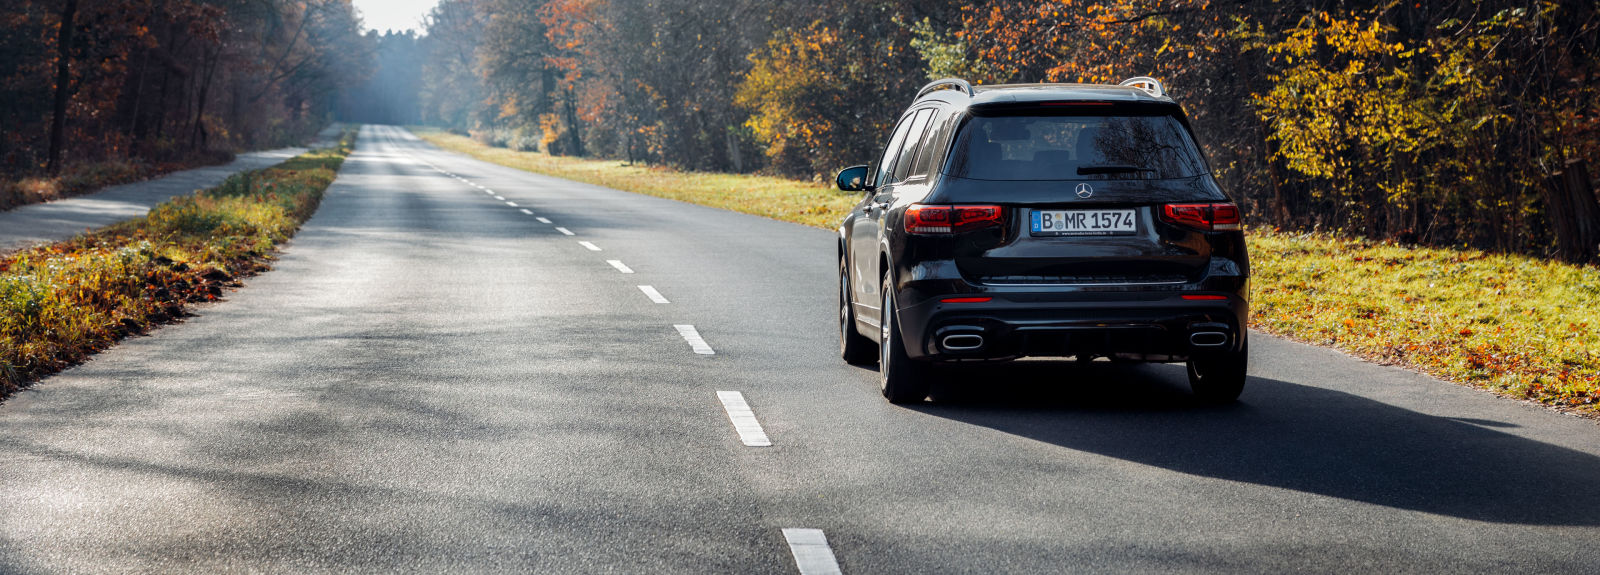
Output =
[{"x1": 899, "y1": 290, "x2": 1250, "y2": 360}]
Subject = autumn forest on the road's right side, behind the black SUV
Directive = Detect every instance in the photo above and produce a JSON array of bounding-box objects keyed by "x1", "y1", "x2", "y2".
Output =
[{"x1": 347, "y1": 0, "x2": 1600, "y2": 261}]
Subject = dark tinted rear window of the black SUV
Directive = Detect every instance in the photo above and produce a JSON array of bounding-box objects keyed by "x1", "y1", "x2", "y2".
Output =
[{"x1": 947, "y1": 115, "x2": 1206, "y2": 179}]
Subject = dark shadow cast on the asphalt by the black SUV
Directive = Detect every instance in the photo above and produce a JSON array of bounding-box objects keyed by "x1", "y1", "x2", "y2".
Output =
[{"x1": 917, "y1": 362, "x2": 1600, "y2": 525}]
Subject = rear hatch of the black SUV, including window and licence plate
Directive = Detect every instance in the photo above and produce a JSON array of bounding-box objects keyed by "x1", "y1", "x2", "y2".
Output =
[{"x1": 926, "y1": 106, "x2": 1227, "y2": 285}]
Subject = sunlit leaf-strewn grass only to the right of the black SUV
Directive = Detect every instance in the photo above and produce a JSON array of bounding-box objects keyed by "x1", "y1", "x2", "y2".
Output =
[{"x1": 1250, "y1": 231, "x2": 1600, "y2": 416}]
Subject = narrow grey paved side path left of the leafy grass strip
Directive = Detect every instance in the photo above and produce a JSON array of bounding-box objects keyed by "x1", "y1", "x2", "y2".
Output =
[{"x1": 0, "y1": 147, "x2": 305, "y2": 253}]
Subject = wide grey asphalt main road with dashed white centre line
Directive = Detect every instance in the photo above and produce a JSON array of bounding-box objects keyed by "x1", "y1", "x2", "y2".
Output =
[{"x1": 0, "y1": 127, "x2": 1600, "y2": 573}]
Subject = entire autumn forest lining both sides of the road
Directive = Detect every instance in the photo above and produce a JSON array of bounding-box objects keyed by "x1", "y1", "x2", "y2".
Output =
[{"x1": 0, "y1": 0, "x2": 1600, "y2": 263}]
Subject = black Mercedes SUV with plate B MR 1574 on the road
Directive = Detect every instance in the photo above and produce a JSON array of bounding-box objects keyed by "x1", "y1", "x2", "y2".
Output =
[{"x1": 838, "y1": 77, "x2": 1250, "y2": 404}]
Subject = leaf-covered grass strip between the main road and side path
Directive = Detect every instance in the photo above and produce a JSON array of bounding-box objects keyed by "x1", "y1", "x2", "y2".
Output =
[{"x1": 0, "y1": 130, "x2": 355, "y2": 396}]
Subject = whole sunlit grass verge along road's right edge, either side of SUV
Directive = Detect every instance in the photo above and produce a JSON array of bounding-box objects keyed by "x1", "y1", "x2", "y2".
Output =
[{"x1": 413, "y1": 128, "x2": 1600, "y2": 416}]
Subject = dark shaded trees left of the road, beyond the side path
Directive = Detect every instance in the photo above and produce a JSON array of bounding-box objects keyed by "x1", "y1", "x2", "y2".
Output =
[{"x1": 0, "y1": 0, "x2": 376, "y2": 208}]
